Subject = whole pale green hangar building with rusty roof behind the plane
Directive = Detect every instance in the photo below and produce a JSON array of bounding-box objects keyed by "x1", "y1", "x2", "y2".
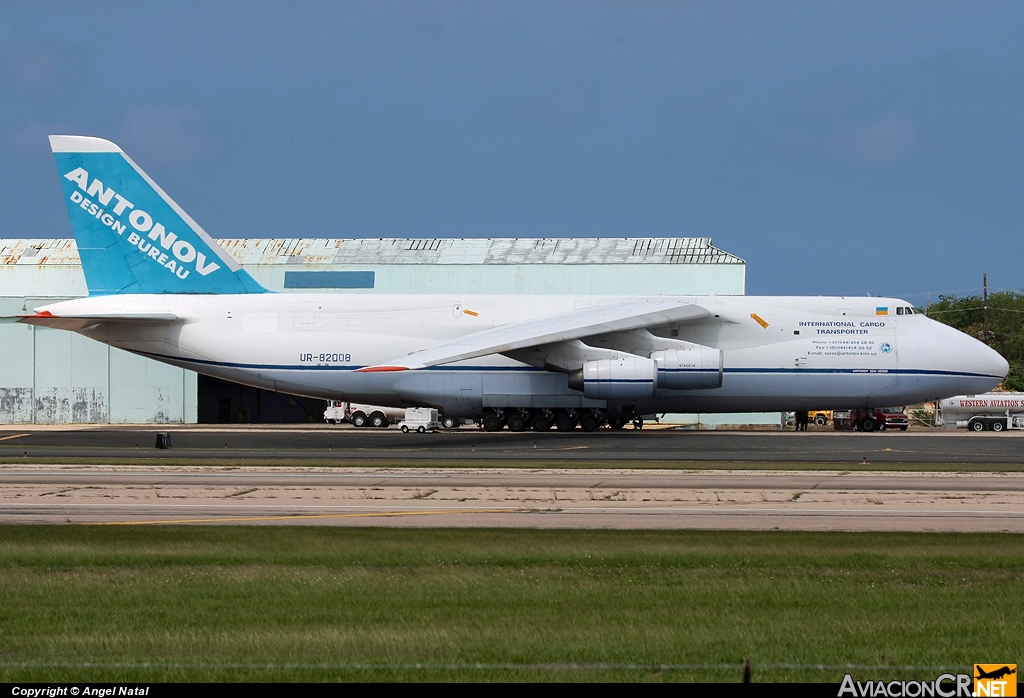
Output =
[{"x1": 0, "y1": 237, "x2": 746, "y2": 424}]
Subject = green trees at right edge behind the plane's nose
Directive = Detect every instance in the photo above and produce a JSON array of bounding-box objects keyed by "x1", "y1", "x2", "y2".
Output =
[{"x1": 925, "y1": 291, "x2": 1024, "y2": 392}]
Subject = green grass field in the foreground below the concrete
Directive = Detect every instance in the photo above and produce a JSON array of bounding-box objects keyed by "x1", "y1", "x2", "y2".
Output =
[{"x1": 0, "y1": 526, "x2": 1024, "y2": 682}]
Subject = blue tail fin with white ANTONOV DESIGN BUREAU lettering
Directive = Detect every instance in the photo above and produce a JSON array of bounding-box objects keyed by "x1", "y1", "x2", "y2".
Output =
[{"x1": 50, "y1": 136, "x2": 267, "y2": 296}]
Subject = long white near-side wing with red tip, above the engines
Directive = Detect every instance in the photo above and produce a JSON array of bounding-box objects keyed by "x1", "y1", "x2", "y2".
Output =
[{"x1": 358, "y1": 299, "x2": 711, "y2": 373}]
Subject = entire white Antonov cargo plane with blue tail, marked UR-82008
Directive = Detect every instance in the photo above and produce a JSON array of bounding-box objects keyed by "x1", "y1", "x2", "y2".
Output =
[{"x1": 22, "y1": 136, "x2": 1009, "y2": 431}]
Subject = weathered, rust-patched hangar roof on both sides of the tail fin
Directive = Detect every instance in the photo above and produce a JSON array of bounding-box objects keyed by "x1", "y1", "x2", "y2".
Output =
[{"x1": 0, "y1": 237, "x2": 744, "y2": 266}]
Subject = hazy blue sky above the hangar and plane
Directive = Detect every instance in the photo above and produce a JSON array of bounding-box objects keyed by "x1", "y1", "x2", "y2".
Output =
[{"x1": 0, "y1": 0, "x2": 1024, "y2": 296}]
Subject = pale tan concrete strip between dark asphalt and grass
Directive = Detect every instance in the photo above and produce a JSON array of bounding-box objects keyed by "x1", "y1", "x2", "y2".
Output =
[{"x1": 0, "y1": 465, "x2": 1024, "y2": 532}]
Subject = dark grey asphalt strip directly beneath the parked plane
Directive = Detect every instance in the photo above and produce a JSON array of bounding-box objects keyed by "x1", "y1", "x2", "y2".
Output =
[{"x1": 0, "y1": 425, "x2": 1024, "y2": 467}]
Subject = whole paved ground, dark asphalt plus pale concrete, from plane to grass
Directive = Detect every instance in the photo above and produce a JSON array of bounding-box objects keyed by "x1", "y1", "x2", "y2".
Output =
[{"x1": 0, "y1": 425, "x2": 1024, "y2": 532}]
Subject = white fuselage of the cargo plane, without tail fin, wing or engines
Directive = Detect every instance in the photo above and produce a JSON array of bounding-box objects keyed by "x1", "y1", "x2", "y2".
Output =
[{"x1": 37, "y1": 294, "x2": 1007, "y2": 416}]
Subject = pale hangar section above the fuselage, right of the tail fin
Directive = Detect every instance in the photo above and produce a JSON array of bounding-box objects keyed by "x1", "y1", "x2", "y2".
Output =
[{"x1": 228, "y1": 237, "x2": 746, "y2": 296}]
